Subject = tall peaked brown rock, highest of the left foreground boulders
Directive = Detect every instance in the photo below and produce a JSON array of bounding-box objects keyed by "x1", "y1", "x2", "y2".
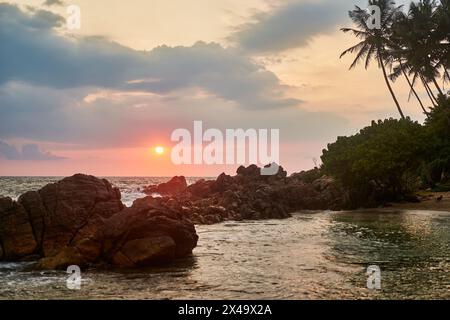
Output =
[{"x1": 22, "y1": 174, "x2": 124, "y2": 256}]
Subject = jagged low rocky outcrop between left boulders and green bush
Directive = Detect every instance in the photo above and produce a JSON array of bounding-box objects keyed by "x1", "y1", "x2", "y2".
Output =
[{"x1": 141, "y1": 165, "x2": 343, "y2": 224}]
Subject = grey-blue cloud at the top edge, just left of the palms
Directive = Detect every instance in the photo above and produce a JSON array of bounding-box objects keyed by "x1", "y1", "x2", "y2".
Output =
[{"x1": 229, "y1": 0, "x2": 358, "y2": 54}]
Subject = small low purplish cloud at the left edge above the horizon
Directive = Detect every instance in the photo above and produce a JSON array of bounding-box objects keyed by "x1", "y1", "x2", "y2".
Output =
[{"x1": 0, "y1": 140, "x2": 65, "y2": 161}]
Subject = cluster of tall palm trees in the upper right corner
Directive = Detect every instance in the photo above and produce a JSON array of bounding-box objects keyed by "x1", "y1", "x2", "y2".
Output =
[{"x1": 341, "y1": 0, "x2": 450, "y2": 118}]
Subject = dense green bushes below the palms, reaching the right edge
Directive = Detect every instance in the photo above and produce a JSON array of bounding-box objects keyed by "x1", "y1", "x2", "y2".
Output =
[{"x1": 321, "y1": 96, "x2": 450, "y2": 205}]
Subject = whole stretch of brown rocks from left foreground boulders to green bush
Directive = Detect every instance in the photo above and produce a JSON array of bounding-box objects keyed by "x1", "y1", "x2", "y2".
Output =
[{"x1": 0, "y1": 165, "x2": 344, "y2": 269}]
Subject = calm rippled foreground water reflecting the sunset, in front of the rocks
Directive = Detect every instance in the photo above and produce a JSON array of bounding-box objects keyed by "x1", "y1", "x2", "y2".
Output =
[{"x1": 0, "y1": 178, "x2": 450, "y2": 299}]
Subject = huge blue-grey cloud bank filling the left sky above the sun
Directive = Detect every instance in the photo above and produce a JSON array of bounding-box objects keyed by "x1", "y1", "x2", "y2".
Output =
[{"x1": 0, "y1": 4, "x2": 348, "y2": 150}]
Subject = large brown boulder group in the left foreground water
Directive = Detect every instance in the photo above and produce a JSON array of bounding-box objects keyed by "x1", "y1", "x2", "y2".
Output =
[{"x1": 0, "y1": 174, "x2": 198, "y2": 269}]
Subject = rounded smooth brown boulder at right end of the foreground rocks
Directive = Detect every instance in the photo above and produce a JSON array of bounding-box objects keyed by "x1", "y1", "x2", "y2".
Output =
[{"x1": 102, "y1": 197, "x2": 198, "y2": 266}]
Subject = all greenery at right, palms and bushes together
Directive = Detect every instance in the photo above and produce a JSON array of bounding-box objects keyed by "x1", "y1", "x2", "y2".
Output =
[{"x1": 320, "y1": 0, "x2": 450, "y2": 205}]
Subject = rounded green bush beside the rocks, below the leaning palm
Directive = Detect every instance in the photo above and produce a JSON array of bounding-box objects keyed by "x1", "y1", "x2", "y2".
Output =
[{"x1": 321, "y1": 118, "x2": 427, "y2": 203}]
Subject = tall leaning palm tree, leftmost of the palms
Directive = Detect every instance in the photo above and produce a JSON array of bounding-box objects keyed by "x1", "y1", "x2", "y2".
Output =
[{"x1": 341, "y1": 0, "x2": 405, "y2": 119}]
